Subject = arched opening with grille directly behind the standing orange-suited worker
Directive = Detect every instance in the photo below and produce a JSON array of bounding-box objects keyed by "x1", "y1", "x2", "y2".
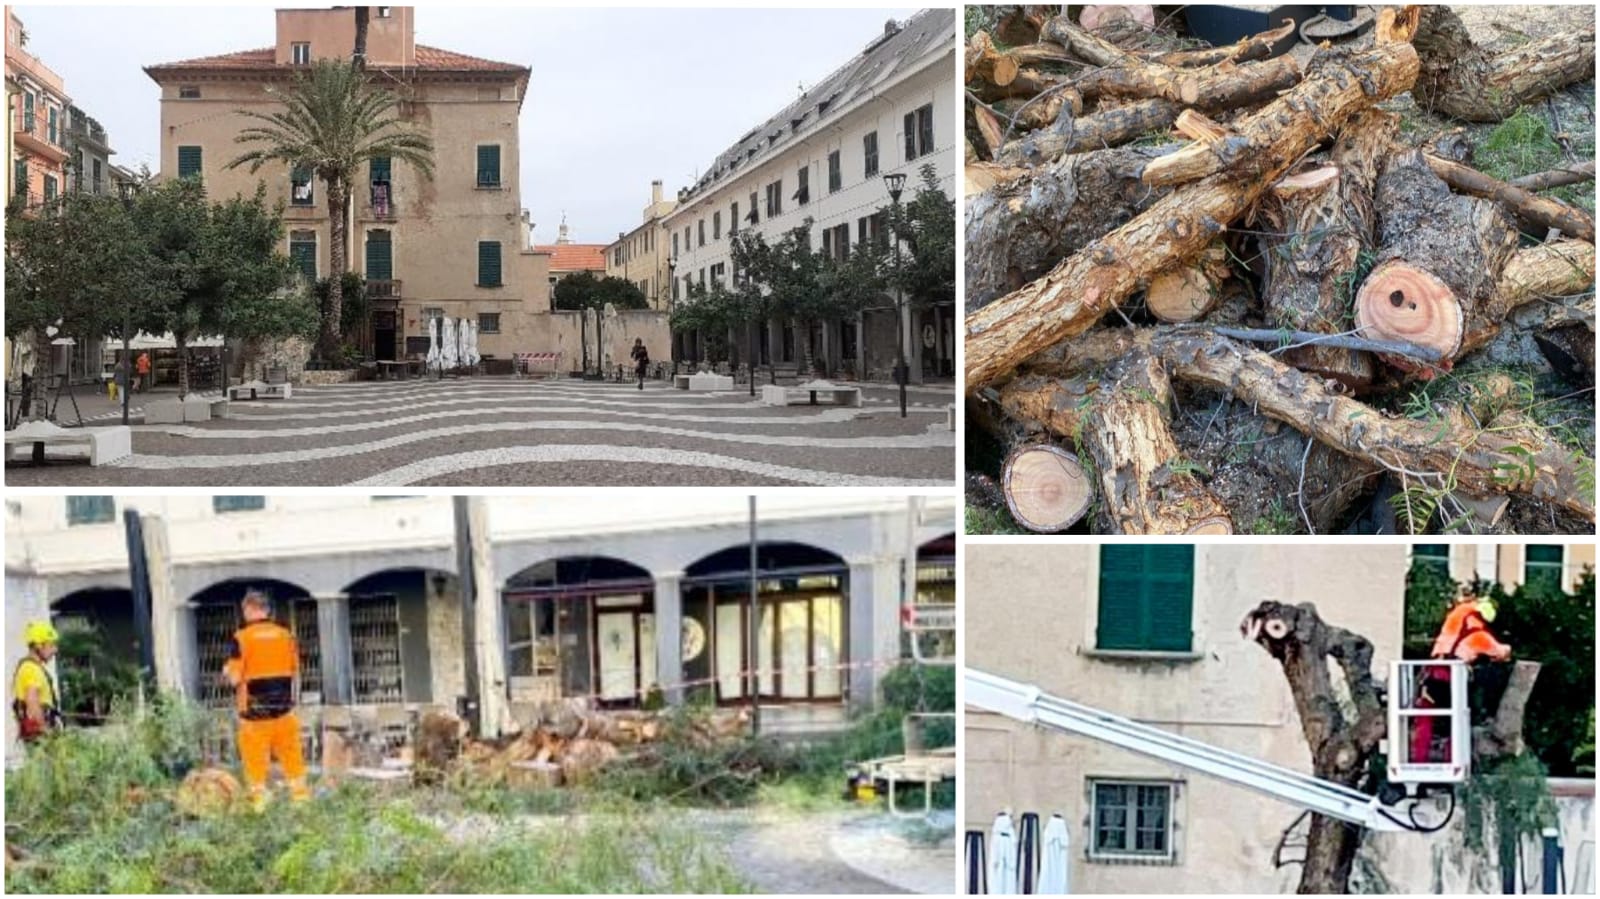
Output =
[{"x1": 189, "y1": 577, "x2": 322, "y2": 709}]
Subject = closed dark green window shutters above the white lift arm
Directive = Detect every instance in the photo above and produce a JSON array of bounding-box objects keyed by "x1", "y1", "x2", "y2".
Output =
[{"x1": 1094, "y1": 544, "x2": 1195, "y2": 653}]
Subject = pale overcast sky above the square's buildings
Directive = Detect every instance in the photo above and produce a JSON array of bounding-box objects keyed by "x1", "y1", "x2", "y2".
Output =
[{"x1": 16, "y1": 6, "x2": 915, "y2": 243}]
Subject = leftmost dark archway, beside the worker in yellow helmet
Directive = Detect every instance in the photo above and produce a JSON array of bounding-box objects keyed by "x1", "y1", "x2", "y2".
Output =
[{"x1": 50, "y1": 587, "x2": 139, "y2": 726}]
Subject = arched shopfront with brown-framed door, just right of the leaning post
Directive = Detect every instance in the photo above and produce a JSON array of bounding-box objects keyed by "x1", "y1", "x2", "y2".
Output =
[{"x1": 502, "y1": 555, "x2": 659, "y2": 707}]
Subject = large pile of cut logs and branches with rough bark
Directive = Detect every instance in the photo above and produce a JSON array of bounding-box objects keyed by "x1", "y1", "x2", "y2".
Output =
[{"x1": 965, "y1": 6, "x2": 1595, "y2": 534}]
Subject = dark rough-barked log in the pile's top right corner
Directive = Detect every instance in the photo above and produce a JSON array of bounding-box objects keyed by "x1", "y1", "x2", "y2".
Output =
[{"x1": 1414, "y1": 6, "x2": 1595, "y2": 122}]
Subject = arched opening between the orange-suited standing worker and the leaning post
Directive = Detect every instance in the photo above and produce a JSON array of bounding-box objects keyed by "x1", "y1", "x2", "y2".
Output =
[{"x1": 341, "y1": 568, "x2": 466, "y2": 705}]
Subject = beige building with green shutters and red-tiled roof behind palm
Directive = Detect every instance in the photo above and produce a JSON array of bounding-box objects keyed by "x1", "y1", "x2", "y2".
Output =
[{"x1": 146, "y1": 6, "x2": 556, "y2": 358}]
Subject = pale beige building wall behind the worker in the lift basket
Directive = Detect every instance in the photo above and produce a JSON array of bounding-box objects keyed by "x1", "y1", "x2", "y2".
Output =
[{"x1": 962, "y1": 544, "x2": 1594, "y2": 894}]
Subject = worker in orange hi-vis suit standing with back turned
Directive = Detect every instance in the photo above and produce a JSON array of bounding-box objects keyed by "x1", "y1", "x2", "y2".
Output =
[{"x1": 224, "y1": 590, "x2": 310, "y2": 811}]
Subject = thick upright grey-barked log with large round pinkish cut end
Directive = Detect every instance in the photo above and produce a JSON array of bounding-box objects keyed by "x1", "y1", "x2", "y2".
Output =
[{"x1": 1355, "y1": 150, "x2": 1517, "y2": 371}]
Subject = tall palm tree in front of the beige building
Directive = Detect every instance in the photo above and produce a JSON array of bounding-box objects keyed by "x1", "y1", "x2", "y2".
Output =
[{"x1": 227, "y1": 59, "x2": 434, "y2": 360}]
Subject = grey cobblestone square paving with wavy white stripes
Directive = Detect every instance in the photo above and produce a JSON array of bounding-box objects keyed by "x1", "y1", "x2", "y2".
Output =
[{"x1": 6, "y1": 378, "x2": 955, "y2": 486}]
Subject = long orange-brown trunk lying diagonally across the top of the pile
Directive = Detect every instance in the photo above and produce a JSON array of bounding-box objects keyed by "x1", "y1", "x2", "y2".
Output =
[{"x1": 965, "y1": 42, "x2": 1418, "y2": 392}]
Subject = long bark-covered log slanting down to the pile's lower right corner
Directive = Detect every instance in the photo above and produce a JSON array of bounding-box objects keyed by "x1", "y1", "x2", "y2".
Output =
[{"x1": 1158, "y1": 333, "x2": 1595, "y2": 521}]
